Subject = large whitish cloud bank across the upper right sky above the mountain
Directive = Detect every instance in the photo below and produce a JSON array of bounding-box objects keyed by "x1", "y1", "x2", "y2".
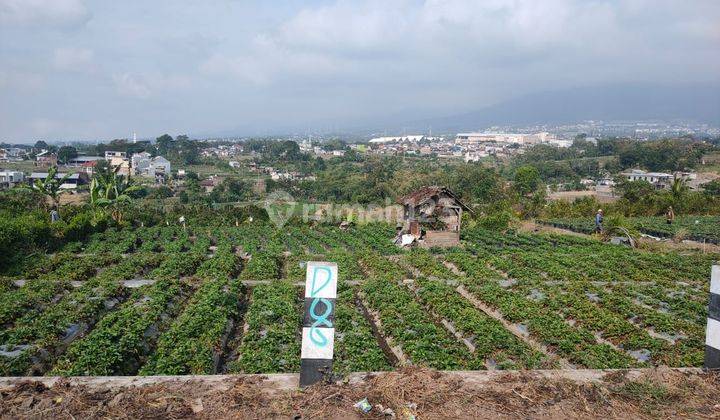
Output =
[{"x1": 195, "y1": 0, "x2": 720, "y2": 90}]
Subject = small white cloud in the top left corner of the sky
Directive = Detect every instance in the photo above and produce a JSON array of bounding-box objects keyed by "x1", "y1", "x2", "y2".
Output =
[{"x1": 0, "y1": 0, "x2": 91, "y2": 28}]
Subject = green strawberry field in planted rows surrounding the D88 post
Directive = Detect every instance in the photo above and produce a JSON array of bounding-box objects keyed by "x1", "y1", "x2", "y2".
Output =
[{"x1": 0, "y1": 224, "x2": 718, "y2": 376}]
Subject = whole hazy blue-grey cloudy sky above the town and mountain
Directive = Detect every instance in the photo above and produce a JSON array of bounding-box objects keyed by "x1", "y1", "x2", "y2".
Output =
[{"x1": 0, "y1": 0, "x2": 720, "y2": 142}]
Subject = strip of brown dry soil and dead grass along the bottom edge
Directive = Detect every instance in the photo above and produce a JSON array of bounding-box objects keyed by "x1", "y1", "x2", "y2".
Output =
[{"x1": 0, "y1": 368, "x2": 720, "y2": 419}]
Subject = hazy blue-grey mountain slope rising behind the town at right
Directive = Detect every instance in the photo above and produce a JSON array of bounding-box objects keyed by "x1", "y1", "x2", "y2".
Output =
[{"x1": 402, "y1": 85, "x2": 720, "y2": 131}]
